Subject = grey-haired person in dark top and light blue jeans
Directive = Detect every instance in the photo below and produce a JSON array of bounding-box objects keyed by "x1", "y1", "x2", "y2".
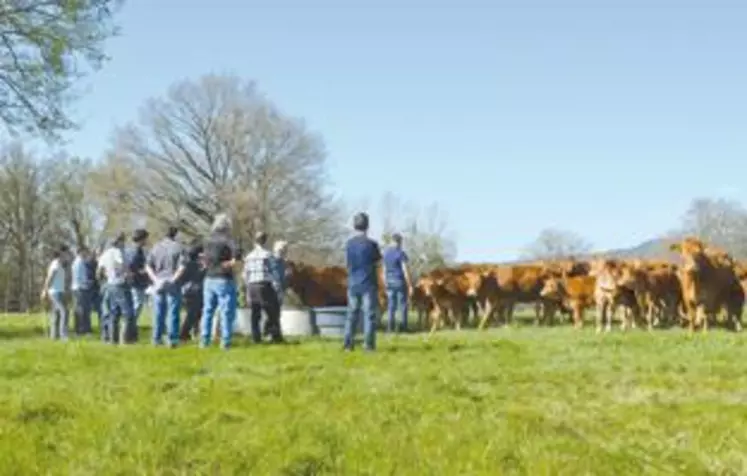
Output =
[{"x1": 200, "y1": 214, "x2": 238, "y2": 350}]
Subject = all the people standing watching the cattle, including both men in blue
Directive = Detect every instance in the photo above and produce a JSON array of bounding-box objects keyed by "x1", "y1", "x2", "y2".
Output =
[{"x1": 42, "y1": 213, "x2": 412, "y2": 351}]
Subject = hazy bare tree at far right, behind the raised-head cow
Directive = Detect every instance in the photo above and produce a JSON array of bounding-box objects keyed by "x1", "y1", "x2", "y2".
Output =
[{"x1": 675, "y1": 198, "x2": 747, "y2": 258}]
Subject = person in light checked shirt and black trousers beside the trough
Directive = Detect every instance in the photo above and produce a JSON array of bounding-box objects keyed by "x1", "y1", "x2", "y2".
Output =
[{"x1": 243, "y1": 232, "x2": 283, "y2": 343}]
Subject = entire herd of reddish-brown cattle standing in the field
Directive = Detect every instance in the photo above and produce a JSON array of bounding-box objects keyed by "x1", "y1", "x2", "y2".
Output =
[{"x1": 288, "y1": 237, "x2": 747, "y2": 332}]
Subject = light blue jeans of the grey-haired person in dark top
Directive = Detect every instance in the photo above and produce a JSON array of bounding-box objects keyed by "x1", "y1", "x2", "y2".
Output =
[{"x1": 200, "y1": 278, "x2": 238, "y2": 348}]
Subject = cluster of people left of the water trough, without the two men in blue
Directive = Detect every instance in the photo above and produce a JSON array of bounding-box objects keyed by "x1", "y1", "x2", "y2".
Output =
[{"x1": 42, "y1": 214, "x2": 287, "y2": 348}]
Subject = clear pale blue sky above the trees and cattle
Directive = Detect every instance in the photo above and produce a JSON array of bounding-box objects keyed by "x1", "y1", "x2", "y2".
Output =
[{"x1": 62, "y1": 0, "x2": 747, "y2": 261}]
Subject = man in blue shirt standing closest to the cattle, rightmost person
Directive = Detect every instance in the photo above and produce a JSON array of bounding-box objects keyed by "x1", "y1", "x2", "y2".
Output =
[{"x1": 383, "y1": 233, "x2": 412, "y2": 332}]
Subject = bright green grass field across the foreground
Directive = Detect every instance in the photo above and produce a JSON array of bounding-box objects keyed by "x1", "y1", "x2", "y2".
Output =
[{"x1": 0, "y1": 317, "x2": 747, "y2": 476}]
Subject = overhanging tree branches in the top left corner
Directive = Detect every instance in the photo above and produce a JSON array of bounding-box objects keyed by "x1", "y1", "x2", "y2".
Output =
[{"x1": 0, "y1": 0, "x2": 122, "y2": 139}]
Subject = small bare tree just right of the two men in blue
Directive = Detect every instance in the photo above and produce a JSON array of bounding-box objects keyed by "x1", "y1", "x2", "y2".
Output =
[{"x1": 378, "y1": 193, "x2": 457, "y2": 276}]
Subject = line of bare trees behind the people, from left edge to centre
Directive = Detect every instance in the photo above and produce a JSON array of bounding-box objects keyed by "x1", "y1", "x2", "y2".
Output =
[{"x1": 0, "y1": 75, "x2": 456, "y2": 312}]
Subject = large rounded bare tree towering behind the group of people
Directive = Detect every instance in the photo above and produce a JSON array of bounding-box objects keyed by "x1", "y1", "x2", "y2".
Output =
[{"x1": 103, "y1": 75, "x2": 342, "y2": 259}]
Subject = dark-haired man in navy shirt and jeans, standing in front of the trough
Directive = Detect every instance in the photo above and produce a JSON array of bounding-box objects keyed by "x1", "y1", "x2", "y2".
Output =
[{"x1": 344, "y1": 213, "x2": 381, "y2": 351}]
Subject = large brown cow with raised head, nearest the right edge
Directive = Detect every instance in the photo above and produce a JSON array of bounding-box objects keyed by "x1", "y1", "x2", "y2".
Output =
[{"x1": 670, "y1": 237, "x2": 745, "y2": 333}]
